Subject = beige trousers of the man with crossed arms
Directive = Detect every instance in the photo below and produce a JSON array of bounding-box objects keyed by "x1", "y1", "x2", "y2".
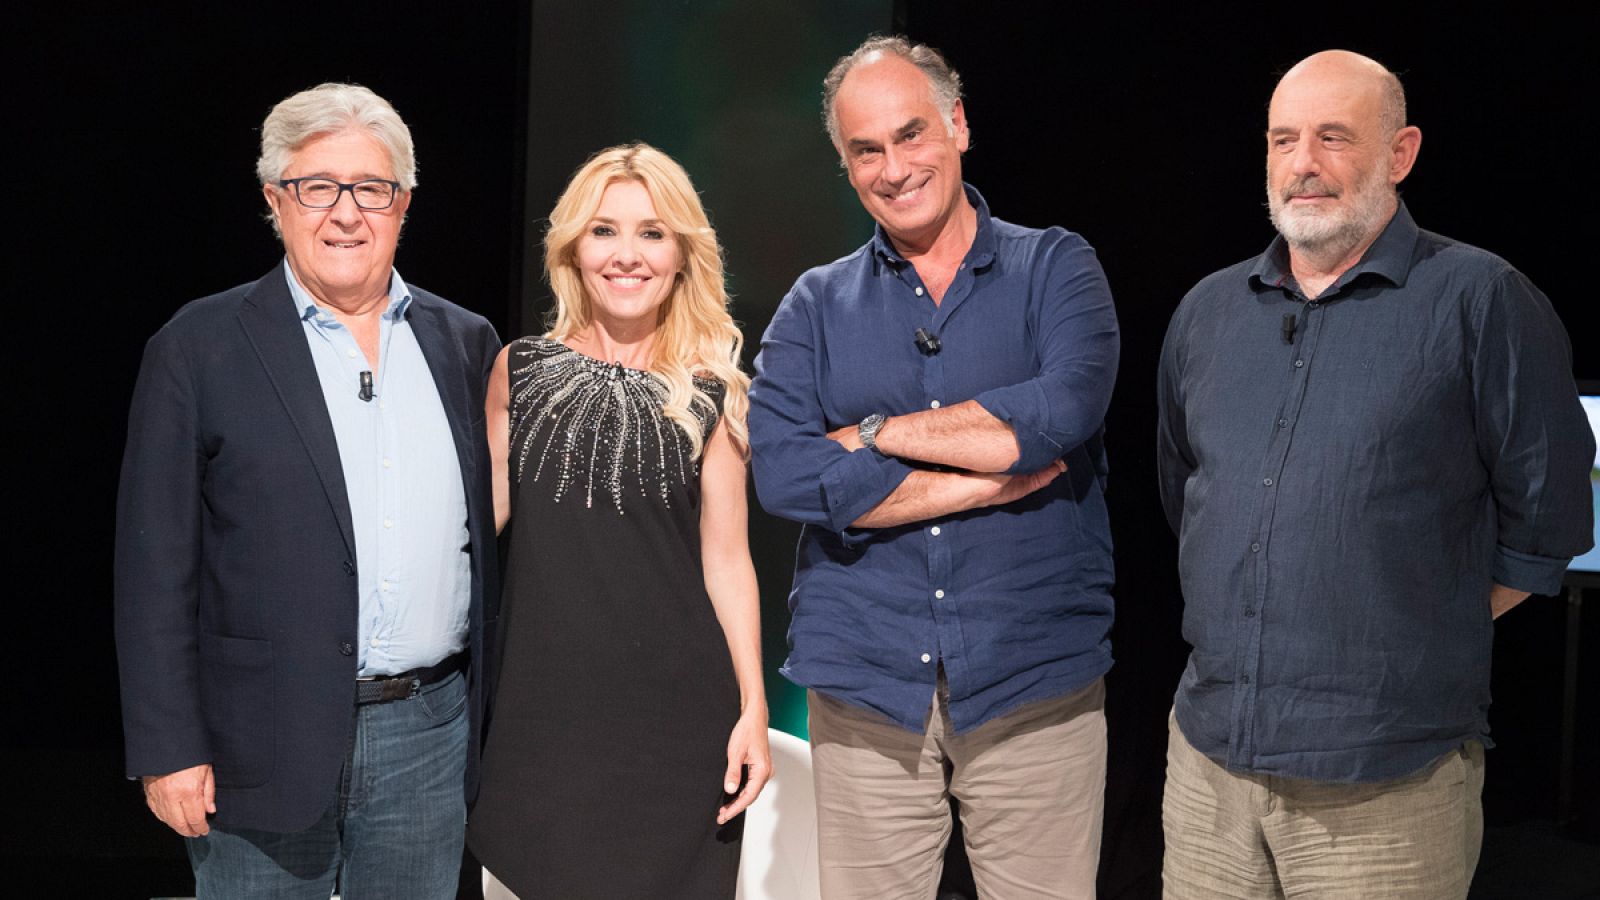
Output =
[{"x1": 808, "y1": 674, "x2": 1106, "y2": 900}]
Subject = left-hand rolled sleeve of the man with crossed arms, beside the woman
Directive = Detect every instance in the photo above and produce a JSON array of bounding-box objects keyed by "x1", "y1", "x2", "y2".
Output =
[{"x1": 750, "y1": 279, "x2": 910, "y2": 533}]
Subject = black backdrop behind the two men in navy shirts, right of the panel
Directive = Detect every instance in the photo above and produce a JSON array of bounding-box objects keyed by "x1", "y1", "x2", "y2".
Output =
[{"x1": 906, "y1": 2, "x2": 1600, "y2": 897}]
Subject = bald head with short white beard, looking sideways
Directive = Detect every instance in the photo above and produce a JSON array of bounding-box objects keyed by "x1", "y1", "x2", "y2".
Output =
[{"x1": 1267, "y1": 51, "x2": 1421, "y2": 255}]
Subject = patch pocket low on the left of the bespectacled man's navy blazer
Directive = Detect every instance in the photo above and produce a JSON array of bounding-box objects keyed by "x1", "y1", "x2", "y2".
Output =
[{"x1": 200, "y1": 633, "x2": 275, "y2": 788}]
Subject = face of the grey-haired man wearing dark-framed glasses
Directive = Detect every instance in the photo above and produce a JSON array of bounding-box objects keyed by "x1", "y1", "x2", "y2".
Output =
[{"x1": 261, "y1": 131, "x2": 411, "y2": 309}]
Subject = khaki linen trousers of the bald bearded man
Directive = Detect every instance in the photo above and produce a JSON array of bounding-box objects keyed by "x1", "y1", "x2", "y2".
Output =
[{"x1": 1162, "y1": 707, "x2": 1483, "y2": 900}]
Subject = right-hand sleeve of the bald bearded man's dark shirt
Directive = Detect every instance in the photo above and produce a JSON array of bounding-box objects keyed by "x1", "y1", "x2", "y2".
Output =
[{"x1": 1472, "y1": 271, "x2": 1595, "y2": 594}]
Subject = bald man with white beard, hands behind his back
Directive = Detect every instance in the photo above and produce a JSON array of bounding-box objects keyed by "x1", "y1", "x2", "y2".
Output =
[{"x1": 1158, "y1": 51, "x2": 1594, "y2": 898}]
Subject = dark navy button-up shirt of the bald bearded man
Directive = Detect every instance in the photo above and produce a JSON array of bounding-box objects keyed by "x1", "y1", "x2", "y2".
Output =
[{"x1": 1158, "y1": 207, "x2": 1594, "y2": 781}]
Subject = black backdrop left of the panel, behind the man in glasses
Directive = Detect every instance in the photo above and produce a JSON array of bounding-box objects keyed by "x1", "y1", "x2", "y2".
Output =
[{"x1": 0, "y1": 0, "x2": 526, "y2": 898}]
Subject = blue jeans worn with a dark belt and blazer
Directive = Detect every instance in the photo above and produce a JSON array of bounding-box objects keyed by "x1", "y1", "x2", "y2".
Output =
[{"x1": 187, "y1": 673, "x2": 467, "y2": 900}]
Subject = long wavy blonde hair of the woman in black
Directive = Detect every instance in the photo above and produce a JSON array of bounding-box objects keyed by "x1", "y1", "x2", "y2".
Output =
[{"x1": 544, "y1": 143, "x2": 750, "y2": 458}]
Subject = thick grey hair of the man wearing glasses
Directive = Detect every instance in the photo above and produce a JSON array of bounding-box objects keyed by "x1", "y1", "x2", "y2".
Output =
[{"x1": 256, "y1": 82, "x2": 416, "y2": 191}]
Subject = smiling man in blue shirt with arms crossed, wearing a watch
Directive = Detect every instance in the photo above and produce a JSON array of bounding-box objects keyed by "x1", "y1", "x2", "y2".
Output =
[{"x1": 750, "y1": 38, "x2": 1118, "y2": 900}]
